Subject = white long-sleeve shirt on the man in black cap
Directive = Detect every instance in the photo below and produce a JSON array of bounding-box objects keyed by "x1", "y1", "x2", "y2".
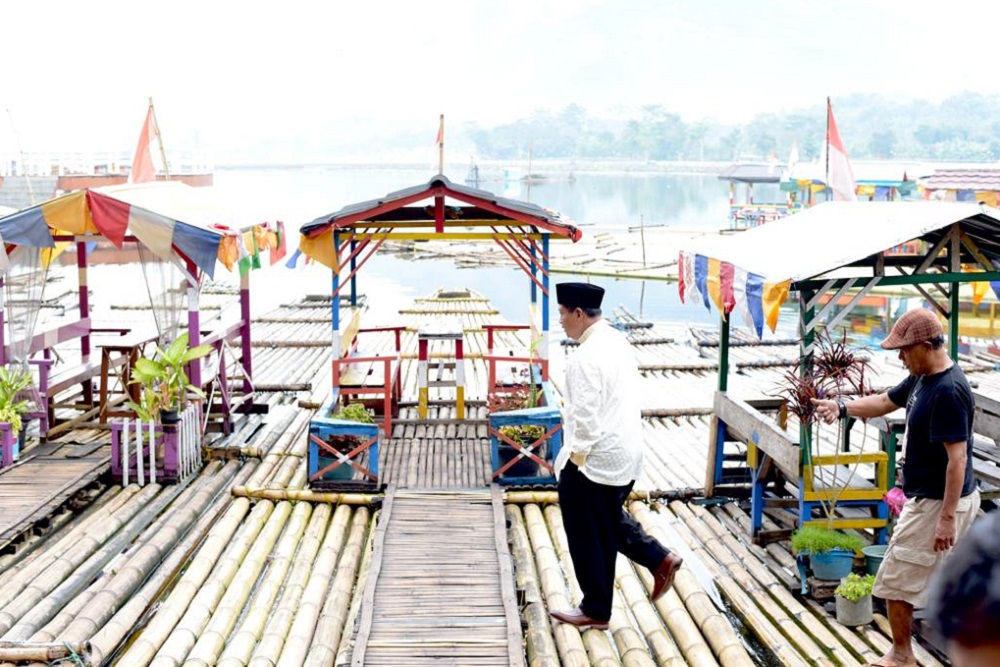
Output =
[{"x1": 556, "y1": 319, "x2": 642, "y2": 486}]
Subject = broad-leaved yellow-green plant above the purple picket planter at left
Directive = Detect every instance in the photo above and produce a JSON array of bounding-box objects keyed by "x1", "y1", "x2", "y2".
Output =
[{"x1": 126, "y1": 333, "x2": 212, "y2": 421}]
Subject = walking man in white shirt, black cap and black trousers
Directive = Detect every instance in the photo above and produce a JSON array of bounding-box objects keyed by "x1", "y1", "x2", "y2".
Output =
[{"x1": 551, "y1": 283, "x2": 683, "y2": 630}]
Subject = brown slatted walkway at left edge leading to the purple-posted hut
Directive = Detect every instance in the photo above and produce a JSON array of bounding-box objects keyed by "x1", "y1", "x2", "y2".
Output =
[{"x1": 0, "y1": 432, "x2": 111, "y2": 549}]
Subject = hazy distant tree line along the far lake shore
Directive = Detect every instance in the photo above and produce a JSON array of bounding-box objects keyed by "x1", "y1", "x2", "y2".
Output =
[{"x1": 466, "y1": 92, "x2": 1000, "y2": 162}]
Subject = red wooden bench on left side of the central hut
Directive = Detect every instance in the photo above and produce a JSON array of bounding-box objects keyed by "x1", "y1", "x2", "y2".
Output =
[{"x1": 332, "y1": 327, "x2": 406, "y2": 438}]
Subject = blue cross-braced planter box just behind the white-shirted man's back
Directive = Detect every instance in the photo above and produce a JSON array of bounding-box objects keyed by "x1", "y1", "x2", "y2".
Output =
[{"x1": 489, "y1": 382, "x2": 562, "y2": 485}]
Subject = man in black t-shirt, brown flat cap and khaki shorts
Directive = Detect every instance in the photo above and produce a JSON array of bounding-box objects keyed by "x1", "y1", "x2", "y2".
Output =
[{"x1": 813, "y1": 308, "x2": 979, "y2": 667}]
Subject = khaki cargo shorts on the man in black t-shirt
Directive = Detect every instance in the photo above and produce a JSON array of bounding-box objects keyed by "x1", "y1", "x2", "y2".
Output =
[{"x1": 872, "y1": 491, "x2": 979, "y2": 608}]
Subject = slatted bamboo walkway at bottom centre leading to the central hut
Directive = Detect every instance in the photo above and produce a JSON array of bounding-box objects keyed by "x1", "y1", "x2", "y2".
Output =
[{"x1": 352, "y1": 486, "x2": 524, "y2": 667}]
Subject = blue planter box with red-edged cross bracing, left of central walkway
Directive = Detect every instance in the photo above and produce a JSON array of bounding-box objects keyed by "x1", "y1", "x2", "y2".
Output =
[{"x1": 309, "y1": 417, "x2": 380, "y2": 488}]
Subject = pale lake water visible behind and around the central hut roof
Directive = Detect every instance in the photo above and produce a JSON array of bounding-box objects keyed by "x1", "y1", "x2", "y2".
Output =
[{"x1": 209, "y1": 166, "x2": 794, "y2": 335}]
